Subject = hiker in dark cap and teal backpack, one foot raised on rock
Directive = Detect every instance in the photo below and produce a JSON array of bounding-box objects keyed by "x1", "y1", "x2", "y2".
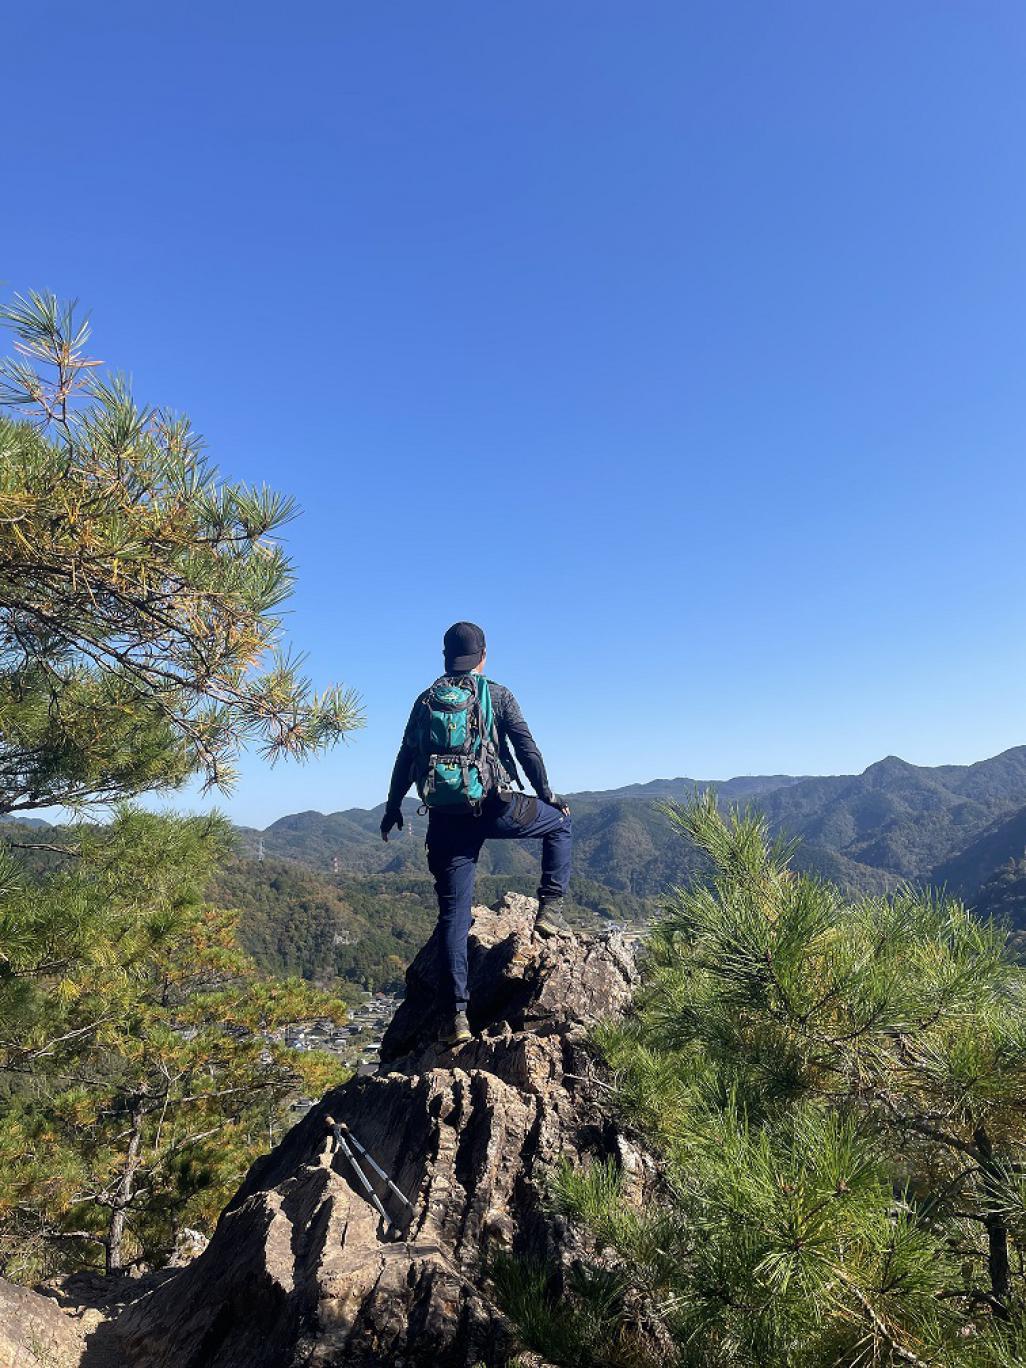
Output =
[{"x1": 382, "y1": 622, "x2": 572, "y2": 1045}]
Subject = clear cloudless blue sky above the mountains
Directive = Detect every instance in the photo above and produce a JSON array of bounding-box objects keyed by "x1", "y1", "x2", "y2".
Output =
[{"x1": 0, "y1": 0, "x2": 1026, "y2": 825}]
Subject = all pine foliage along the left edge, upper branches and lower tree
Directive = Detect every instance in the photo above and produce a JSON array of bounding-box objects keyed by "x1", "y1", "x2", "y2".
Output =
[{"x1": 0, "y1": 294, "x2": 361, "y2": 1279}]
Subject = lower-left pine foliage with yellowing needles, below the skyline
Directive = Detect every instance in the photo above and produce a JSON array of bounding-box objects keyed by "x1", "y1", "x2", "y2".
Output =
[{"x1": 0, "y1": 810, "x2": 345, "y2": 1279}]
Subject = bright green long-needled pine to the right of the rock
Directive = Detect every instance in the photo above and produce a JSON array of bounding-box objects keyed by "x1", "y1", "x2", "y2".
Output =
[{"x1": 511, "y1": 799, "x2": 1026, "y2": 1368}]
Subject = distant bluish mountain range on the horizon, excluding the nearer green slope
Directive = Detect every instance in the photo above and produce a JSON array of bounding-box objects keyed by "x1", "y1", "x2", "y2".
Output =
[{"x1": 242, "y1": 747, "x2": 1026, "y2": 904}]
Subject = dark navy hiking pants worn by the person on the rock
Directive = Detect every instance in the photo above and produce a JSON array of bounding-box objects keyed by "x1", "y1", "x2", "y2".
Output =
[{"x1": 427, "y1": 793, "x2": 573, "y2": 1011}]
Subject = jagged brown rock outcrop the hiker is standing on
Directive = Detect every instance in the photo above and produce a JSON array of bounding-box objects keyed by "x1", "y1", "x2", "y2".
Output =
[{"x1": 102, "y1": 895, "x2": 636, "y2": 1368}]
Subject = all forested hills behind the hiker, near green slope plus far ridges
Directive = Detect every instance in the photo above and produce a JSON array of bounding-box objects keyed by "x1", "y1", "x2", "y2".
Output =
[{"x1": 8, "y1": 747, "x2": 1026, "y2": 995}]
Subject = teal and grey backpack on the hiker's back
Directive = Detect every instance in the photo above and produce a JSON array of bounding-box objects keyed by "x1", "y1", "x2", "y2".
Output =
[{"x1": 416, "y1": 674, "x2": 510, "y2": 813}]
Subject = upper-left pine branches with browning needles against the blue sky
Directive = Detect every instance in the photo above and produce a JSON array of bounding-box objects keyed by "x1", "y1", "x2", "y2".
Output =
[{"x1": 0, "y1": 294, "x2": 360, "y2": 813}]
